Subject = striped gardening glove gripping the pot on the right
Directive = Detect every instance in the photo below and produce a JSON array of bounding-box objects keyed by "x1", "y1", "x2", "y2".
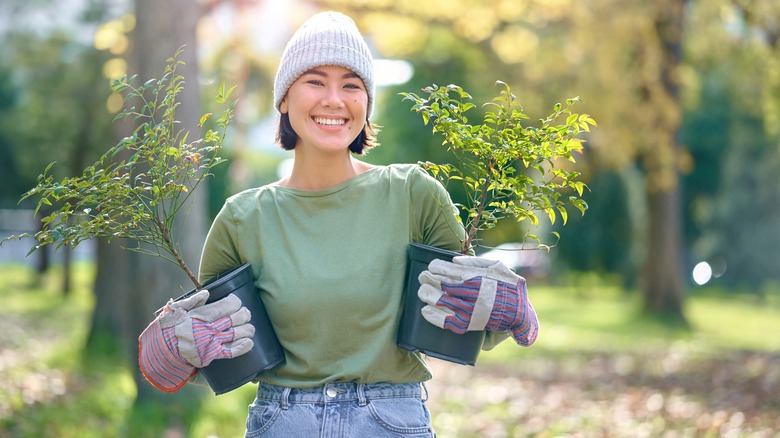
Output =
[{"x1": 417, "y1": 256, "x2": 539, "y2": 347}]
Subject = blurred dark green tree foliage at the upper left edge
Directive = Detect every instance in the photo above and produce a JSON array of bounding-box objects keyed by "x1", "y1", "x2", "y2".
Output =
[{"x1": 0, "y1": 29, "x2": 112, "y2": 208}]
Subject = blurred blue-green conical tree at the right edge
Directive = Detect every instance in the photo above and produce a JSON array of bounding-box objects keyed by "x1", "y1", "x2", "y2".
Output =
[{"x1": 708, "y1": 115, "x2": 780, "y2": 294}]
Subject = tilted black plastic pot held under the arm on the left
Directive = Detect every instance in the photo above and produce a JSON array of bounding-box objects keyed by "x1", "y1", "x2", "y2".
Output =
[{"x1": 177, "y1": 263, "x2": 284, "y2": 395}]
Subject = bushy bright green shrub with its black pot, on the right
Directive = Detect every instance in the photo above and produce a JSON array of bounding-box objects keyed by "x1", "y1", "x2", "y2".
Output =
[{"x1": 398, "y1": 81, "x2": 596, "y2": 365}]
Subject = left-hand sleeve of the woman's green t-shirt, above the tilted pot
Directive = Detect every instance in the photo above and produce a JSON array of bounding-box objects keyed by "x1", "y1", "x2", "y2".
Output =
[{"x1": 198, "y1": 202, "x2": 241, "y2": 282}]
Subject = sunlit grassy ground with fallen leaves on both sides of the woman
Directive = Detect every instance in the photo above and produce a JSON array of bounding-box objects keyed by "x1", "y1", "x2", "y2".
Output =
[{"x1": 0, "y1": 264, "x2": 780, "y2": 438}]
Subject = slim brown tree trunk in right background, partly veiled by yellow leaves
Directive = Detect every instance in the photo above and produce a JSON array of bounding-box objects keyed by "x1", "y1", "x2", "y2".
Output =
[{"x1": 644, "y1": 0, "x2": 685, "y2": 322}]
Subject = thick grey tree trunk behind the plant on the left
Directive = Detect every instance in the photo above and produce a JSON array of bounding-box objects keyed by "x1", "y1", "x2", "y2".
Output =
[{"x1": 89, "y1": 0, "x2": 207, "y2": 403}]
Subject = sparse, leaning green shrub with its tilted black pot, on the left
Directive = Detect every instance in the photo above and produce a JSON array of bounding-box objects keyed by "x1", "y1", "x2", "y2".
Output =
[{"x1": 0, "y1": 49, "x2": 284, "y2": 394}]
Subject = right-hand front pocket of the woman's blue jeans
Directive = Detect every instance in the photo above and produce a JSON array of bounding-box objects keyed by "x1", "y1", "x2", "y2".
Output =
[{"x1": 367, "y1": 398, "x2": 433, "y2": 437}]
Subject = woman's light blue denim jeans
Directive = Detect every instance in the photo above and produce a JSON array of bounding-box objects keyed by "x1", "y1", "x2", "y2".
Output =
[{"x1": 245, "y1": 382, "x2": 435, "y2": 438}]
